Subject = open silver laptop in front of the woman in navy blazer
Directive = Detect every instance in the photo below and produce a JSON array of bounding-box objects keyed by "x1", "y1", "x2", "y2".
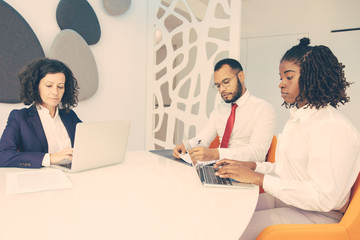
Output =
[{"x1": 51, "y1": 120, "x2": 130, "y2": 172}]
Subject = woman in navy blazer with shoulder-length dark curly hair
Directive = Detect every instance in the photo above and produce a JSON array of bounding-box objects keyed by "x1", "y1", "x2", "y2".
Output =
[{"x1": 0, "y1": 58, "x2": 81, "y2": 168}]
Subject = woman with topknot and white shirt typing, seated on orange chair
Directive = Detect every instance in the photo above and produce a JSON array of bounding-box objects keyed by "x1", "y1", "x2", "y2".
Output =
[{"x1": 214, "y1": 38, "x2": 360, "y2": 240}]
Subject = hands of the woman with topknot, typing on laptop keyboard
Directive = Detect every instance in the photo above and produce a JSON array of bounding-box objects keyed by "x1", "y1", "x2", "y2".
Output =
[{"x1": 214, "y1": 159, "x2": 264, "y2": 186}]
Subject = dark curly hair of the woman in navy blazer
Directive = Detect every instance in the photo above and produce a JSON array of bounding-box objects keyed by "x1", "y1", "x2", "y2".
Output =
[{"x1": 18, "y1": 58, "x2": 79, "y2": 111}]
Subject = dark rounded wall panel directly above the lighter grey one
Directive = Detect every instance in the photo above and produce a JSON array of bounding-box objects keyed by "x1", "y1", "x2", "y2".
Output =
[{"x1": 56, "y1": 0, "x2": 101, "y2": 45}]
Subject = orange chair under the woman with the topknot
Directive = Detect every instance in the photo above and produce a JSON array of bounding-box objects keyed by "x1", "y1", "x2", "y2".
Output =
[{"x1": 256, "y1": 173, "x2": 360, "y2": 240}]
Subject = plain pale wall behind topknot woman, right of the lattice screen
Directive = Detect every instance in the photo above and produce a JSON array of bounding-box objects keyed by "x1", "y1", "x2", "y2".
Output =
[{"x1": 240, "y1": 0, "x2": 360, "y2": 134}]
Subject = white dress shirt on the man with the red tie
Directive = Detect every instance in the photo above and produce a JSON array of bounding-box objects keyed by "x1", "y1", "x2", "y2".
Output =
[{"x1": 189, "y1": 90, "x2": 276, "y2": 162}]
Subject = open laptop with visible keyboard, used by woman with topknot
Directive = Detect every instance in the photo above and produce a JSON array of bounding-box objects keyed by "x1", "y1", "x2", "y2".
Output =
[{"x1": 183, "y1": 134, "x2": 253, "y2": 188}]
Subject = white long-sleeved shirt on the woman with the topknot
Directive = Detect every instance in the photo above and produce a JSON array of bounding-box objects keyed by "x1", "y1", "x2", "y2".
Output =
[{"x1": 255, "y1": 106, "x2": 360, "y2": 212}]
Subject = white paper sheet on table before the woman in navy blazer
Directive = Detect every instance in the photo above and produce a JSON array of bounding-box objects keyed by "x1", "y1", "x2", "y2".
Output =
[{"x1": 6, "y1": 168, "x2": 73, "y2": 194}]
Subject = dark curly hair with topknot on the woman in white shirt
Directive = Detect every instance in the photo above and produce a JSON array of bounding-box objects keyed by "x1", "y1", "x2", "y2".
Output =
[{"x1": 280, "y1": 38, "x2": 351, "y2": 109}]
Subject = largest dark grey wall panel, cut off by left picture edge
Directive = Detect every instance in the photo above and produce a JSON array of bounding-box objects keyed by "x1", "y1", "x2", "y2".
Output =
[{"x1": 0, "y1": 1, "x2": 44, "y2": 103}]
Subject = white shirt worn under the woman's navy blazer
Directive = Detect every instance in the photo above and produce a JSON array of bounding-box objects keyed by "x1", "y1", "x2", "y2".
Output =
[{"x1": 36, "y1": 105, "x2": 71, "y2": 166}]
